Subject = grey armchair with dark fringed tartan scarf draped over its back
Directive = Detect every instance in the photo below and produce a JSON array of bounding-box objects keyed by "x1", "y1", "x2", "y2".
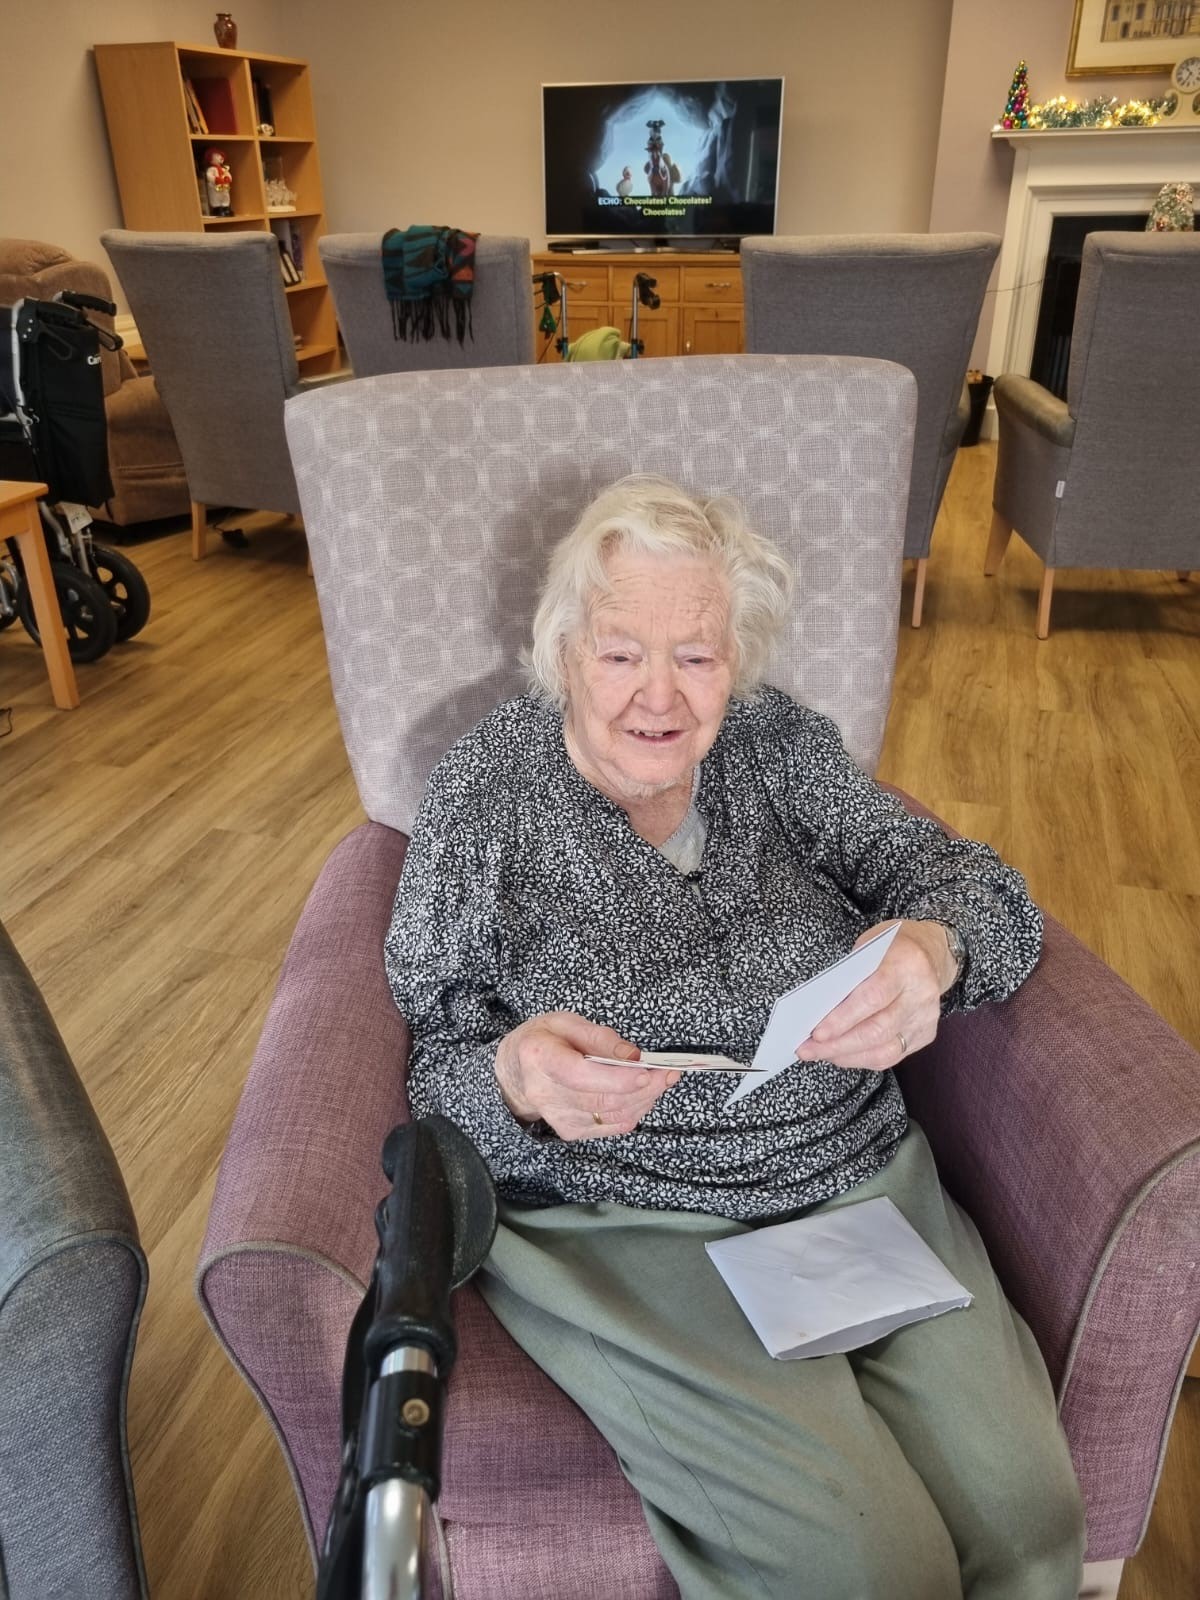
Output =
[{"x1": 317, "y1": 234, "x2": 534, "y2": 378}]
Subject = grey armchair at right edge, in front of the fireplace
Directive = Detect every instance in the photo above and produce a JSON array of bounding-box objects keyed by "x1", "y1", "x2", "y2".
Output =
[{"x1": 984, "y1": 234, "x2": 1200, "y2": 638}]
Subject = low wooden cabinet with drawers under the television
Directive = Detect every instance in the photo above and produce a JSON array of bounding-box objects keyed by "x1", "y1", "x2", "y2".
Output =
[{"x1": 533, "y1": 250, "x2": 742, "y2": 362}]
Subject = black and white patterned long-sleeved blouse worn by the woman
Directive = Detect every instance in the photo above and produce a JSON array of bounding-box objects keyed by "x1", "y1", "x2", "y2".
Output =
[{"x1": 386, "y1": 688, "x2": 1042, "y2": 1221}]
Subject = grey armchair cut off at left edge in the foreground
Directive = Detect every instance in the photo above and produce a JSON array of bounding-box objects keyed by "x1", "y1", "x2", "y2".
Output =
[{"x1": 0, "y1": 928, "x2": 147, "y2": 1600}]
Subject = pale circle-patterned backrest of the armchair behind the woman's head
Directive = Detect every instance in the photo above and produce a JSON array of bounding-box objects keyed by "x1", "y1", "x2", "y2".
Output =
[{"x1": 286, "y1": 355, "x2": 917, "y2": 830}]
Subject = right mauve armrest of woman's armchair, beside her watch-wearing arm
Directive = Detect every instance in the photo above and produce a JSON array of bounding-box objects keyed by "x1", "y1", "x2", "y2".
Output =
[{"x1": 901, "y1": 917, "x2": 1200, "y2": 1560}]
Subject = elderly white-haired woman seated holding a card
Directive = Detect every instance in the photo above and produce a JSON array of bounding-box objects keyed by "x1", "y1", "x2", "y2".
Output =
[{"x1": 387, "y1": 478, "x2": 1083, "y2": 1600}]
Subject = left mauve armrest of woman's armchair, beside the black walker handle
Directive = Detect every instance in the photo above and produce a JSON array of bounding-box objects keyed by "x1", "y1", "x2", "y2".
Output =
[{"x1": 197, "y1": 822, "x2": 408, "y2": 1544}]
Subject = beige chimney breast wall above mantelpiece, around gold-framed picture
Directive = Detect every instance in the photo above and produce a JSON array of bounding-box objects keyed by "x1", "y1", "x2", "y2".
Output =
[{"x1": 930, "y1": 0, "x2": 1166, "y2": 366}]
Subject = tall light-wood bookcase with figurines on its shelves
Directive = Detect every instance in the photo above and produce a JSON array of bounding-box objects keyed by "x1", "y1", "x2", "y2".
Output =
[{"x1": 94, "y1": 42, "x2": 341, "y2": 374}]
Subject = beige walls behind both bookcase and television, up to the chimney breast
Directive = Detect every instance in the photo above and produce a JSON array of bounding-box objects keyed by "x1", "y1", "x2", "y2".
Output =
[{"x1": 0, "y1": 0, "x2": 952, "y2": 305}]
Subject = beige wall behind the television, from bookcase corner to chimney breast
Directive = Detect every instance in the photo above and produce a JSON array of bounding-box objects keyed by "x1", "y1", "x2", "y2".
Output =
[{"x1": 298, "y1": 0, "x2": 950, "y2": 245}]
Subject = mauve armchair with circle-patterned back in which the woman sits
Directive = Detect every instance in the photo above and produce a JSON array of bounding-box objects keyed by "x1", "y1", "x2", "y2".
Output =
[{"x1": 198, "y1": 357, "x2": 1200, "y2": 1600}]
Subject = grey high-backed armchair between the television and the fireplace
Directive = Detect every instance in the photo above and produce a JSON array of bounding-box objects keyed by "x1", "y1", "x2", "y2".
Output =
[{"x1": 742, "y1": 234, "x2": 1000, "y2": 627}]
